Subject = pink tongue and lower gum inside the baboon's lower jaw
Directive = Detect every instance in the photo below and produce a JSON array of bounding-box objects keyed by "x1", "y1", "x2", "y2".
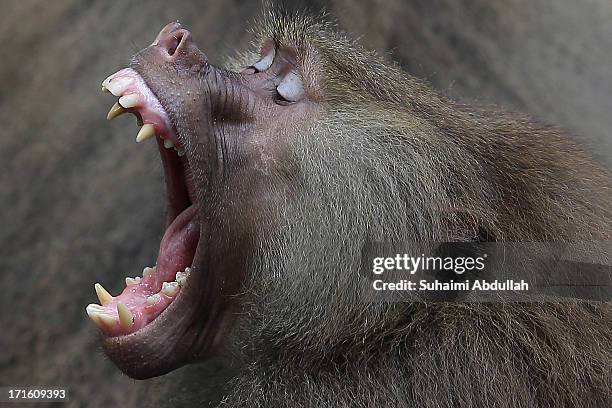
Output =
[{"x1": 95, "y1": 205, "x2": 200, "y2": 336}]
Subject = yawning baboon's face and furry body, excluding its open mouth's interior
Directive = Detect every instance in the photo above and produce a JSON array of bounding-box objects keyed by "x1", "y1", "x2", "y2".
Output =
[{"x1": 93, "y1": 7, "x2": 612, "y2": 406}]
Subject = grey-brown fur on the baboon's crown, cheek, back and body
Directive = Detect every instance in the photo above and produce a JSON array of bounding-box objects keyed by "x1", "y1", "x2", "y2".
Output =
[{"x1": 218, "y1": 7, "x2": 612, "y2": 407}]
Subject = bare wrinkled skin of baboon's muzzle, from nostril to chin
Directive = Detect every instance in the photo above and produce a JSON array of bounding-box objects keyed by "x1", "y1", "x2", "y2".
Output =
[{"x1": 104, "y1": 23, "x2": 317, "y2": 378}]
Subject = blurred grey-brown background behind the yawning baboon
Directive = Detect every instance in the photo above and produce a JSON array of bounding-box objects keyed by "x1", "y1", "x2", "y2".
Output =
[{"x1": 0, "y1": 0, "x2": 612, "y2": 407}]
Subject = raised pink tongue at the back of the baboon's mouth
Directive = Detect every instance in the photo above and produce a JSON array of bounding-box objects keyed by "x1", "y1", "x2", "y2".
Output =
[{"x1": 154, "y1": 205, "x2": 200, "y2": 288}]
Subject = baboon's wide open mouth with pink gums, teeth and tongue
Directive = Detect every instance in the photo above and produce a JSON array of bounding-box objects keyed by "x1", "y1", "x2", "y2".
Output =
[{"x1": 86, "y1": 68, "x2": 200, "y2": 337}]
